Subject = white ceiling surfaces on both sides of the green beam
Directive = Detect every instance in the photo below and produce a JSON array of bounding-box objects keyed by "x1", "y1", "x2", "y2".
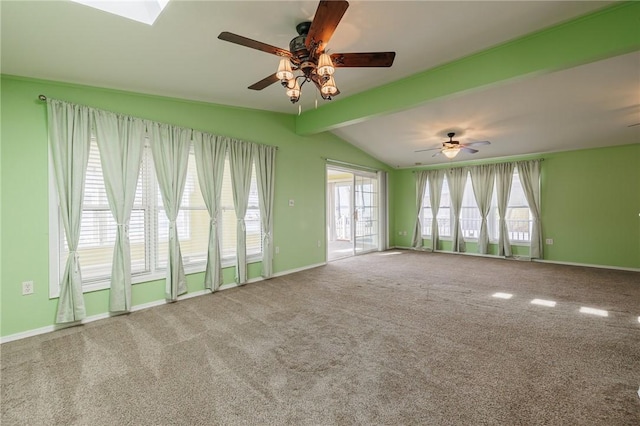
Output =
[{"x1": 0, "y1": 0, "x2": 640, "y2": 167}]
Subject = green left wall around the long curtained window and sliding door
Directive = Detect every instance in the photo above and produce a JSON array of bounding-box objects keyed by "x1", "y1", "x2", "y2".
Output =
[{"x1": 0, "y1": 75, "x2": 389, "y2": 336}]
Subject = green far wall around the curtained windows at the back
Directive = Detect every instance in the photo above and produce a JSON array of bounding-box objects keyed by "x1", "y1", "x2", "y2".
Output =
[{"x1": 391, "y1": 143, "x2": 640, "y2": 269}]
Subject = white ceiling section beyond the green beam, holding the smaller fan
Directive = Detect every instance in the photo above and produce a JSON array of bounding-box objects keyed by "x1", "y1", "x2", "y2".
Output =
[{"x1": 334, "y1": 52, "x2": 640, "y2": 167}]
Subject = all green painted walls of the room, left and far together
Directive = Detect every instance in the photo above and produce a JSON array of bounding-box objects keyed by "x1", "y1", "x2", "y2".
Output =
[{"x1": 0, "y1": 76, "x2": 640, "y2": 336}]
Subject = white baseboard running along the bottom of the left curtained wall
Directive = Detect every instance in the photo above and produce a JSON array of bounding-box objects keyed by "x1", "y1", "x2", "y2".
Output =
[{"x1": 0, "y1": 262, "x2": 326, "y2": 344}]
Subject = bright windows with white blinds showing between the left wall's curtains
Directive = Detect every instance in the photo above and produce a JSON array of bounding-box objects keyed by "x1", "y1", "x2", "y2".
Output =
[{"x1": 50, "y1": 138, "x2": 262, "y2": 297}]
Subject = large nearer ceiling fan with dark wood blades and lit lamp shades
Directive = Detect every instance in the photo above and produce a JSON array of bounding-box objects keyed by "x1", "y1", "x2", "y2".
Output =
[{"x1": 218, "y1": 0, "x2": 396, "y2": 103}]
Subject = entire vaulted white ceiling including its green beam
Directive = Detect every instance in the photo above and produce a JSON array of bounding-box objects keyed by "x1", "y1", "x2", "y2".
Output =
[{"x1": 0, "y1": 0, "x2": 640, "y2": 167}]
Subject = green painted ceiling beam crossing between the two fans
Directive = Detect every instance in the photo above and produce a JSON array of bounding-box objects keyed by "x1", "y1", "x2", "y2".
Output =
[{"x1": 296, "y1": 2, "x2": 640, "y2": 135}]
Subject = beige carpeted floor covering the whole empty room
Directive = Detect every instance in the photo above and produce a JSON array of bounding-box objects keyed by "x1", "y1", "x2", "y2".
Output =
[{"x1": 0, "y1": 251, "x2": 640, "y2": 425}]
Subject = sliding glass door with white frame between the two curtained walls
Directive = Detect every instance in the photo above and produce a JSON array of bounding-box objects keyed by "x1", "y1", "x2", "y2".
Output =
[{"x1": 327, "y1": 165, "x2": 381, "y2": 261}]
